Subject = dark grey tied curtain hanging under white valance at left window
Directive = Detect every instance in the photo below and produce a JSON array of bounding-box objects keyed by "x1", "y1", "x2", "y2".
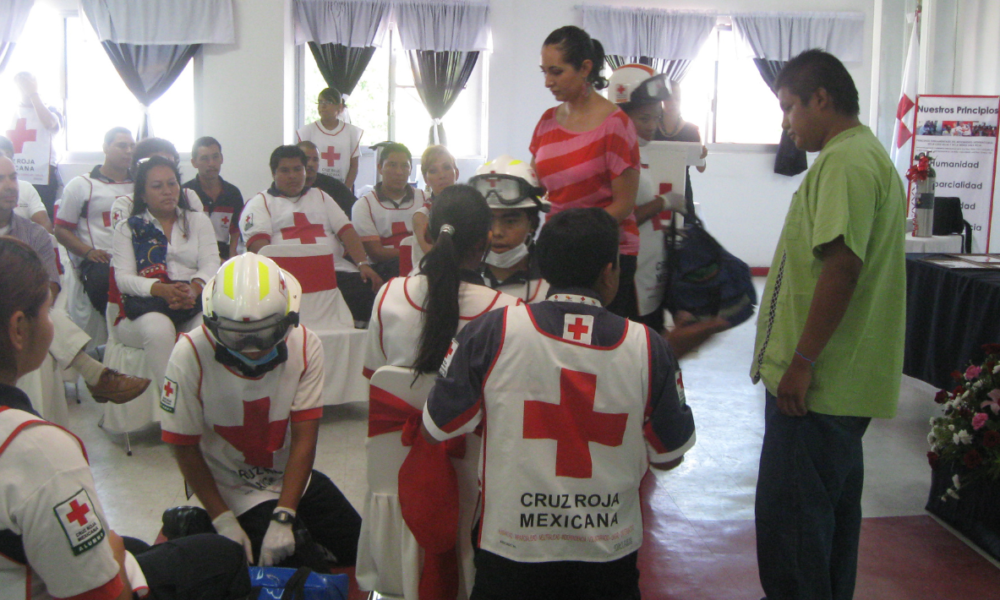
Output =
[{"x1": 101, "y1": 41, "x2": 201, "y2": 140}]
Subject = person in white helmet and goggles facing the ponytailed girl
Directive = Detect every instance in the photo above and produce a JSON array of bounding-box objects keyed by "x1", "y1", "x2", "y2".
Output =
[{"x1": 469, "y1": 154, "x2": 550, "y2": 303}]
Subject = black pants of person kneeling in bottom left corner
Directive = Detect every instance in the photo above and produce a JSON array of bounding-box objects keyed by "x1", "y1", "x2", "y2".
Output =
[{"x1": 123, "y1": 533, "x2": 250, "y2": 600}]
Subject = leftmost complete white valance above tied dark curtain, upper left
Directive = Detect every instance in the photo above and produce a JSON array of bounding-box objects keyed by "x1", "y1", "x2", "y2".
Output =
[{"x1": 80, "y1": 0, "x2": 236, "y2": 45}]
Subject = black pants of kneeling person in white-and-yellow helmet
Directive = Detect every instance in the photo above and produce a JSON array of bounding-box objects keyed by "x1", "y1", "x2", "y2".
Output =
[{"x1": 238, "y1": 470, "x2": 361, "y2": 567}]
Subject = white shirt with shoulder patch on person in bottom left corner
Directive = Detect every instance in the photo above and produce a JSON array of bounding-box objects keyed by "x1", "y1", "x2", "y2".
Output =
[{"x1": 0, "y1": 407, "x2": 123, "y2": 600}]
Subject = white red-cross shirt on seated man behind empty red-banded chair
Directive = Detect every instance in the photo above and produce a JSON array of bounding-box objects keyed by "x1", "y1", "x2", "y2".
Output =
[{"x1": 240, "y1": 187, "x2": 353, "y2": 254}]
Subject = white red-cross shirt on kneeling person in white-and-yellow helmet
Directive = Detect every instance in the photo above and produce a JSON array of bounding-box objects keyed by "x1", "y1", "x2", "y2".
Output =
[{"x1": 160, "y1": 325, "x2": 323, "y2": 515}]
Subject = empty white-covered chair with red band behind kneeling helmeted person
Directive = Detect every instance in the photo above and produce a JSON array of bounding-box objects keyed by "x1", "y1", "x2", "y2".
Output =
[{"x1": 260, "y1": 244, "x2": 368, "y2": 405}]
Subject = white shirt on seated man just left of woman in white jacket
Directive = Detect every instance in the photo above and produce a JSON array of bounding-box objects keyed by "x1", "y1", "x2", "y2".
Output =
[{"x1": 55, "y1": 167, "x2": 133, "y2": 260}]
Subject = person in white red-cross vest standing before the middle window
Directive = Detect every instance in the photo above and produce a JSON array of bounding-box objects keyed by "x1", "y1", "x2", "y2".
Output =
[{"x1": 295, "y1": 88, "x2": 364, "y2": 190}]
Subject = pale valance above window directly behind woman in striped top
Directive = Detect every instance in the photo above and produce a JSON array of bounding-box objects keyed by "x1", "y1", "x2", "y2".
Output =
[{"x1": 577, "y1": 6, "x2": 717, "y2": 60}]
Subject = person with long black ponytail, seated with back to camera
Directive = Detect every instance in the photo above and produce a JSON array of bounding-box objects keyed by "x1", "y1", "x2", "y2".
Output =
[{"x1": 364, "y1": 185, "x2": 519, "y2": 377}]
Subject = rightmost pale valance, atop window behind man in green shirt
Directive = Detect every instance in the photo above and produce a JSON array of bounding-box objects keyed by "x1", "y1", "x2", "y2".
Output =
[{"x1": 732, "y1": 12, "x2": 865, "y2": 63}]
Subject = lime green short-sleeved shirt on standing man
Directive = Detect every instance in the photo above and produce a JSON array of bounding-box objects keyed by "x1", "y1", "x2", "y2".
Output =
[{"x1": 750, "y1": 125, "x2": 906, "y2": 418}]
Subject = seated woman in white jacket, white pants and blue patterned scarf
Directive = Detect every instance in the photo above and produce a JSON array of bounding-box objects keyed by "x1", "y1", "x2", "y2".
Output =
[{"x1": 111, "y1": 156, "x2": 219, "y2": 385}]
